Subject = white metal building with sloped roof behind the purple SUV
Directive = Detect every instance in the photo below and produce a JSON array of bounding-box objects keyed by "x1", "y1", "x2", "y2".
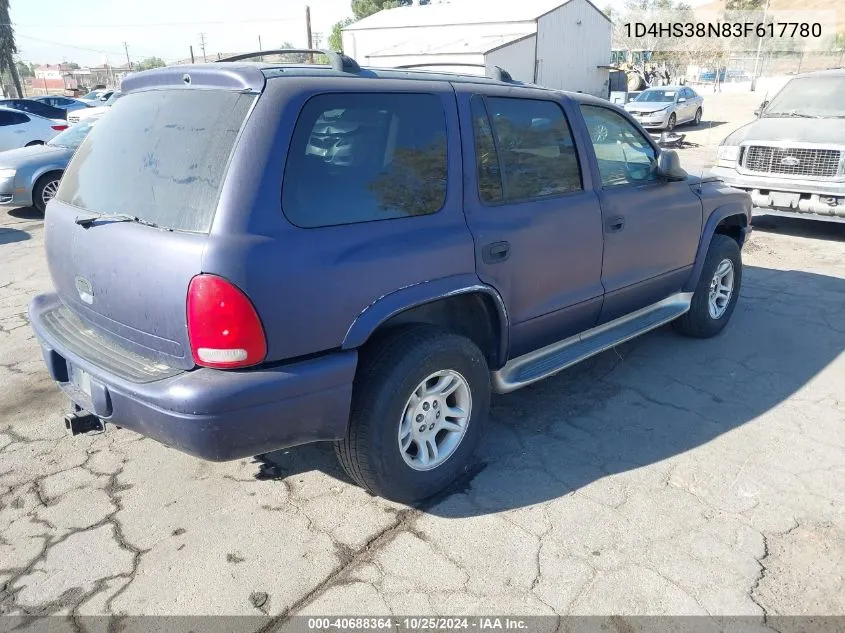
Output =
[{"x1": 343, "y1": 0, "x2": 612, "y2": 97}]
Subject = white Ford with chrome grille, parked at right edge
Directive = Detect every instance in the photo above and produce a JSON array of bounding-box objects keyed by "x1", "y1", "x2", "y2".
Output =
[{"x1": 710, "y1": 69, "x2": 845, "y2": 222}]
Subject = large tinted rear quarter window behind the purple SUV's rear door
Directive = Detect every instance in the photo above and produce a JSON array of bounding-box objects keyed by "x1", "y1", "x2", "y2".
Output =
[{"x1": 282, "y1": 93, "x2": 447, "y2": 228}]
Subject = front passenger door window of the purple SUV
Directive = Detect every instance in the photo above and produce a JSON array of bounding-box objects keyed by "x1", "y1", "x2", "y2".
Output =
[{"x1": 581, "y1": 105, "x2": 657, "y2": 187}]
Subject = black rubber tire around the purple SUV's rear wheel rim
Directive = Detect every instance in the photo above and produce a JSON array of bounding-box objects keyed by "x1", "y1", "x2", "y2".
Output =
[{"x1": 335, "y1": 325, "x2": 490, "y2": 503}]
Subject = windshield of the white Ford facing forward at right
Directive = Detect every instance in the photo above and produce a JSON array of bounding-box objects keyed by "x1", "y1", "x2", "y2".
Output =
[{"x1": 763, "y1": 75, "x2": 845, "y2": 117}]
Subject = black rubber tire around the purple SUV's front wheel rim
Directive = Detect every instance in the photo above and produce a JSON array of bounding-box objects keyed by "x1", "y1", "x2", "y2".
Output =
[{"x1": 673, "y1": 235, "x2": 742, "y2": 338}]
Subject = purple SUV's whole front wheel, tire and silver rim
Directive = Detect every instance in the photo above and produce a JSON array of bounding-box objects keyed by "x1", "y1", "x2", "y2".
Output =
[{"x1": 674, "y1": 235, "x2": 742, "y2": 338}]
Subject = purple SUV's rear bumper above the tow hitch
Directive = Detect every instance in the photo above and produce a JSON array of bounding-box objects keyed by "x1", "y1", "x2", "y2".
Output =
[{"x1": 29, "y1": 294, "x2": 357, "y2": 461}]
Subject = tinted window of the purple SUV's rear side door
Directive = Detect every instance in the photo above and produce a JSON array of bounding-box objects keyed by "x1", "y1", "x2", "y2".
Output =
[{"x1": 473, "y1": 98, "x2": 581, "y2": 202}]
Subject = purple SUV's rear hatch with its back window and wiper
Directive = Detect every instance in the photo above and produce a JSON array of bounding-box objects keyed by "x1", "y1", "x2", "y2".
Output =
[{"x1": 45, "y1": 67, "x2": 263, "y2": 369}]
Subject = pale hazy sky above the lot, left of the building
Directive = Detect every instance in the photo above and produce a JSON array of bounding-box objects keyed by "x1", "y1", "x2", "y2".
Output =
[{"x1": 10, "y1": 0, "x2": 352, "y2": 65}]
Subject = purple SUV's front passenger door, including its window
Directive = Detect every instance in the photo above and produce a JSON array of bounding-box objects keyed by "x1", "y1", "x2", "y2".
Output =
[{"x1": 581, "y1": 104, "x2": 702, "y2": 322}]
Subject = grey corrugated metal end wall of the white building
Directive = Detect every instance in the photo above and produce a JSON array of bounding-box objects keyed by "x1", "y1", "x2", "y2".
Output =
[{"x1": 537, "y1": 0, "x2": 611, "y2": 98}]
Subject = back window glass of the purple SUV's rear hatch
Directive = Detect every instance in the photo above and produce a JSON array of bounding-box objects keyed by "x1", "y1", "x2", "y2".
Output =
[{"x1": 56, "y1": 89, "x2": 255, "y2": 233}]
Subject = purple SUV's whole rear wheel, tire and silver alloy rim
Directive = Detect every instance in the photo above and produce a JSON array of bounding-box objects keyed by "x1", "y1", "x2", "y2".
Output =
[{"x1": 335, "y1": 325, "x2": 490, "y2": 503}]
